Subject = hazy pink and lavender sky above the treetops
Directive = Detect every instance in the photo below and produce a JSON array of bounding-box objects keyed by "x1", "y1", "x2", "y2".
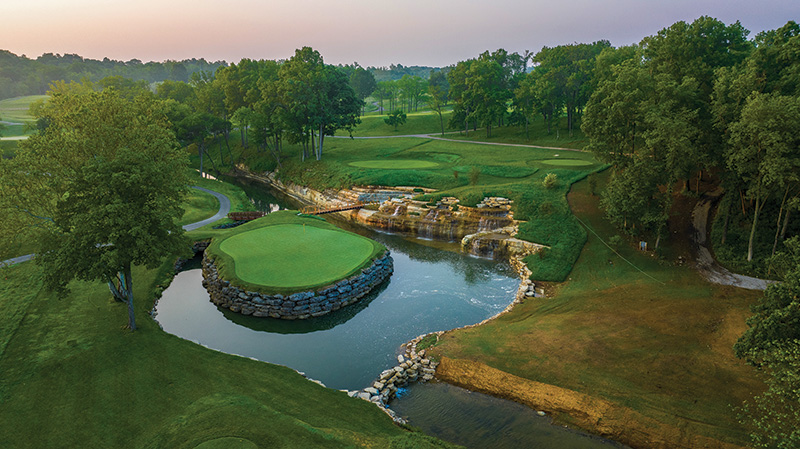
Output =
[{"x1": 0, "y1": 0, "x2": 800, "y2": 67}]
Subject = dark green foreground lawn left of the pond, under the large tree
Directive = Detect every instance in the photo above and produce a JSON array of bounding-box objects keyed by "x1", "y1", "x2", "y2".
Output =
[{"x1": 0, "y1": 181, "x2": 451, "y2": 448}]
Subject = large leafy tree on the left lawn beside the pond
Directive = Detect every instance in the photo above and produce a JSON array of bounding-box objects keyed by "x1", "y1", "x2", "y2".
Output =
[{"x1": 0, "y1": 84, "x2": 187, "y2": 330}]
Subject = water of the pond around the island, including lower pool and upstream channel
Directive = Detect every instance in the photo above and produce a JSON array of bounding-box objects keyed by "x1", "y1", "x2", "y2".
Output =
[{"x1": 155, "y1": 178, "x2": 621, "y2": 449}]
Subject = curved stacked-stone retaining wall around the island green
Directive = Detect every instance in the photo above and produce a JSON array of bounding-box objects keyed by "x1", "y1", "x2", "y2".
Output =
[{"x1": 203, "y1": 251, "x2": 394, "y2": 320}]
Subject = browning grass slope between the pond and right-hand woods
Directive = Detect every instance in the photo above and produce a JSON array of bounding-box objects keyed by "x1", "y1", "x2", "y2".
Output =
[{"x1": 434, "y1": 172, "x2": 763, "y2": 444}]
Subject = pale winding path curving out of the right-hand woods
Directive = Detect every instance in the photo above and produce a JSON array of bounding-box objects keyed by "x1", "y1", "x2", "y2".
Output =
[{"x1": 692, "y1": 187, "x2": 774, "y2": 290}]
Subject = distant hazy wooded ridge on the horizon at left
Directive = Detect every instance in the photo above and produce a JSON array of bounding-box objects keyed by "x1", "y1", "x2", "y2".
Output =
[{"x1": 0, "y1": 50, "x2": 227, "y2": 99}]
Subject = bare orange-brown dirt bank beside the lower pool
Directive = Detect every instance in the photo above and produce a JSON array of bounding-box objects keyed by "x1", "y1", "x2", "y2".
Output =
[{"x1": 436, "y1": 357, "x2": 744, "y2": 449}]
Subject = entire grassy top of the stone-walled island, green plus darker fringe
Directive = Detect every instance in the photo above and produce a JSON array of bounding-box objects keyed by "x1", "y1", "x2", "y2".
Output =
[{"x1": 207, "y1": 211, "x2": 386, "y2": 293}]
